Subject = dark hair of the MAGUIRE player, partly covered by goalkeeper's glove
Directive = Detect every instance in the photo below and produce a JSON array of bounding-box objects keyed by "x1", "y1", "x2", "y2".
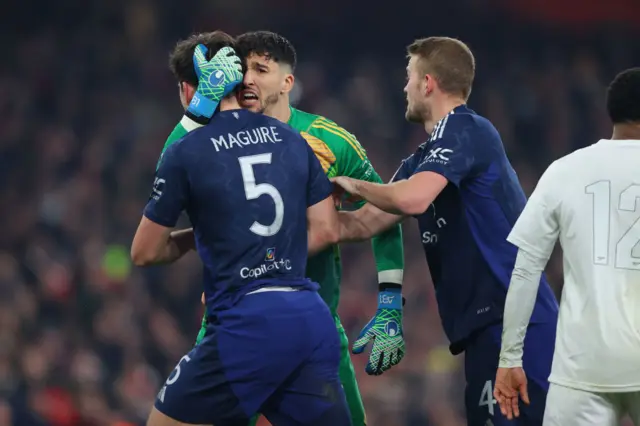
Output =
[{"x1": 169, "y1": 31, "x2": 235, "y2": 86}]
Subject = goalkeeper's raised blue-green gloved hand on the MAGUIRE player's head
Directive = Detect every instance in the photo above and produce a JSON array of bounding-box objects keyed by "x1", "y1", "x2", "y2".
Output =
[{"x1": 186, "y1": 44, "x2": 243, "y2": 124}]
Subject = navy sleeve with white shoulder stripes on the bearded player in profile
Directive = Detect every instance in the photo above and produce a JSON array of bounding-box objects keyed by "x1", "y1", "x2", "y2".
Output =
[{"x1": 413, "y1": 114, "x2": 493, "y2": 186}]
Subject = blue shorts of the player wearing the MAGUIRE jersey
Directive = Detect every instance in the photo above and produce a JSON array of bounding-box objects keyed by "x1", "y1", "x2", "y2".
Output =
[{"x1": 155, "y1": 290, "x2": 351, "y2": 426}]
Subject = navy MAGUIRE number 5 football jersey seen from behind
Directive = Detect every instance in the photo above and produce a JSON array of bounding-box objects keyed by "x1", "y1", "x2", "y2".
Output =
[{"x1": 144, "y1": 110, "x2": 332, "y2": 314}]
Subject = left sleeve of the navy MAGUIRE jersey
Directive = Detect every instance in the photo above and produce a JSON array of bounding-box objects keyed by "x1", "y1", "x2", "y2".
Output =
[{"x1": 144, "y1": 143, "x2": 189, "y2": 228}]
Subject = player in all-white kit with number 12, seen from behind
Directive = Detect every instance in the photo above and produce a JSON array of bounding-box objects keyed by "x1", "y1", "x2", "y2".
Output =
[{"x1": 494, "y1": 68, "x2": 640, "y2": 426}]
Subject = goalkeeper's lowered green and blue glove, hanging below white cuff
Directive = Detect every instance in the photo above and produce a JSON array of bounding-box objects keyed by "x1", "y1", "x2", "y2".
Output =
[{"x1": 352, "y1": 284, "x2": 405, "y2": 376}]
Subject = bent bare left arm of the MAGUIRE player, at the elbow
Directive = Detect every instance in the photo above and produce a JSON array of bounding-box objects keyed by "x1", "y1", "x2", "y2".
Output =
[{"x1": 131, "y1": 217, "x2": 195, "y2": 266}]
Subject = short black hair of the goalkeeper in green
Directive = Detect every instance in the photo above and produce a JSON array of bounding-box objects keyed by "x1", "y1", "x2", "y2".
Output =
[{"x1": 236, "y1": 31, "x2": 297, "y2": 71}]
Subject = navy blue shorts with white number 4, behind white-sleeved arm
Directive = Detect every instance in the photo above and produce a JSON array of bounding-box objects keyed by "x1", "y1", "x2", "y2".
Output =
[{"x1": 465, "y1": 322, "x2": 556, "y2": 426}]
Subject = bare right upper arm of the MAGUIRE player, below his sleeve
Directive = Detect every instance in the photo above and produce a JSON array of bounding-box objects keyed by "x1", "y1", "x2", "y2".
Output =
[{"x1": 307, "y1": 196, "x2": 340, "y2": 256}]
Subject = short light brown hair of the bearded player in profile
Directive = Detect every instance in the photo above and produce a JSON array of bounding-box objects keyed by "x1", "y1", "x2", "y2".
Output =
[{"x1": 407, "y1": 37, "x2": 476, "y2": 100}]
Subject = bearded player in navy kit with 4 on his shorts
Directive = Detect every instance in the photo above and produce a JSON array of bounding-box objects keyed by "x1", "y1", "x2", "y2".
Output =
[{"x1": 334, "y1": 37, "x2": 558, "y2": 426}]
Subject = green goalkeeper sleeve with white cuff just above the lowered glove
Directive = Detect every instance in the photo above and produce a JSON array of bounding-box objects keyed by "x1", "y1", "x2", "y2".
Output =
[{"x1": 371, "y1": 224, "x2": 404, "y2": 284}]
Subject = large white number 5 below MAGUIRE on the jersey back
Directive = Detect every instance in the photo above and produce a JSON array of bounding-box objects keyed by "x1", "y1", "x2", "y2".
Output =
[{"x1": 238, "y1": 152, "x2": 284, "y2": 237}]
